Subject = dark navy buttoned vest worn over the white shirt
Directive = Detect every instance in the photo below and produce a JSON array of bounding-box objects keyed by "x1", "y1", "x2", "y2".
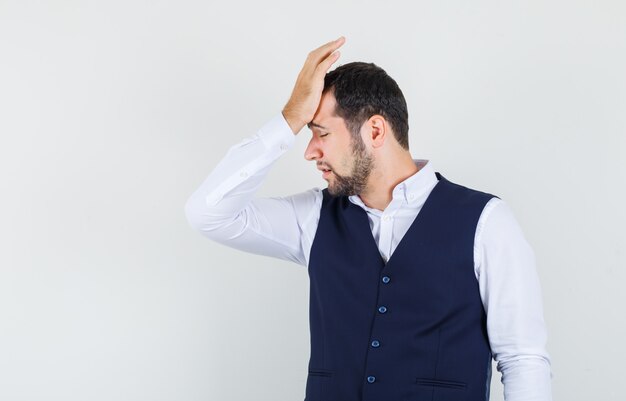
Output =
[{"x1": 305, "y1": 173, "x2": 494, "y2": 401}]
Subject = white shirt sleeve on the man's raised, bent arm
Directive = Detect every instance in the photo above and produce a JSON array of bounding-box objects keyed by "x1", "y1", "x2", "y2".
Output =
[{"x1": 185, "y1": 113, "x2": 322, "y2": 265}]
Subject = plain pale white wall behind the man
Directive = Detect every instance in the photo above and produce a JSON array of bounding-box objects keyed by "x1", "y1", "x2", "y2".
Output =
[{"x1": 0, "y1": 0, "x2": 626, "y2": 401}]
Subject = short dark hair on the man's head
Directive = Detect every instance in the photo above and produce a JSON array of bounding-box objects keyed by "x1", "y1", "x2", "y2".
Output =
[{"x1": 324, "y1": 61, "x2": 409, "y2": 150}]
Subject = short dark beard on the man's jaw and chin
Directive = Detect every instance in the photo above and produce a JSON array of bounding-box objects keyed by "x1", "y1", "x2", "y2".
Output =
[{"x1": 328, "y1": 136, "x2": 374, "y2": 196}]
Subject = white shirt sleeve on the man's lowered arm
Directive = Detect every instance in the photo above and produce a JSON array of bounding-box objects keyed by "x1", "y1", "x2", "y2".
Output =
[{"x1": 474, "y1": 198, "x2": 552, "y2": 401}]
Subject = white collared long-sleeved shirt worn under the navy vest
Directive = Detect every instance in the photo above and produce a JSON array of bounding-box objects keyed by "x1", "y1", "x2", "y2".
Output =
[{"x1": 185, "y1": 113, "x2": 552, "y2": 401}]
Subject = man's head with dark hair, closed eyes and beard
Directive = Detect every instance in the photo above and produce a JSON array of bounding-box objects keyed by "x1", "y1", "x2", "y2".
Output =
[{"x1": 305, "y1": 62, "x2": 409, "y2": 196}]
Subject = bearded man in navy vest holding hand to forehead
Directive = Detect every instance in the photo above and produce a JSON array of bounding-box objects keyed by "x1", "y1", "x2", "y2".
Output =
[{"x1": 185, "y1": 37, "x2": 551, "y2": 401}]
